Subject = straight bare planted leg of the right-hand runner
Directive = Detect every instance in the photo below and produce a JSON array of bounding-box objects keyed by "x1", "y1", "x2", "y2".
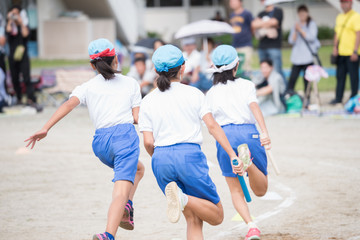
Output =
[{"x1": 225, "y1": 177, "x2": 252, "y2": 223}]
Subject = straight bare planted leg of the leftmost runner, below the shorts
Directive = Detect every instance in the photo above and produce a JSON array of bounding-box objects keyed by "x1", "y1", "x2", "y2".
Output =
[{"x1": 106, "y1": 180, "x2": 133, "y2": 237}]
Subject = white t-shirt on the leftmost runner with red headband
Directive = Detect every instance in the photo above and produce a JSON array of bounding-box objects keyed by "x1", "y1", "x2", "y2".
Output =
[{"x1": 70, "y1": 74, "x2": 141, "y2": 129}]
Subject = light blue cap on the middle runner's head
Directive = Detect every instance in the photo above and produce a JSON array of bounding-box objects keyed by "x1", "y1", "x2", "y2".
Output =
[{"x1": 152, "y1": 44, "x2": 185, "y2": 72}]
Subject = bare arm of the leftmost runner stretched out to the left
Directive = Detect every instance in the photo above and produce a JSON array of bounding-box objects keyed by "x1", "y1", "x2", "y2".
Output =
[{"x1": 25, "y1": 97, "x2": 80, "y2": 149}]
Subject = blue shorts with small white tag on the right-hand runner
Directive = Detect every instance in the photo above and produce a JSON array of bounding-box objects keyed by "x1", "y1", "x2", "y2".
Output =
[{"x1": 216, "y1": 124, "x2": 267, "y2": 177}]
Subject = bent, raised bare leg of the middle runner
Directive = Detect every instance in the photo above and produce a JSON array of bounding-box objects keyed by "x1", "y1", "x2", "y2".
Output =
[{"x1": 184, "y1": 195, "x2": 224, "y2": 225}]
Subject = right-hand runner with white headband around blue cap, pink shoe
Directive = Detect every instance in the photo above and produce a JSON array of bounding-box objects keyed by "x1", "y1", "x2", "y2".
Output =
[{"x1": 206, "y1": 45, "x2": 271, "y2": 240}]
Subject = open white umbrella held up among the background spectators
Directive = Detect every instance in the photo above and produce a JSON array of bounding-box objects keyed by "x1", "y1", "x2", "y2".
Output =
[{"x1": 175, "y1": 20, "x2": 235, "y2": 39}]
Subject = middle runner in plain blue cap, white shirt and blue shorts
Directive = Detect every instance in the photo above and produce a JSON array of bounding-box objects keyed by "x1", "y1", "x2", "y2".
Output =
[{"x1": 139, "y1": 45, "x2": 243, "y2": 239}]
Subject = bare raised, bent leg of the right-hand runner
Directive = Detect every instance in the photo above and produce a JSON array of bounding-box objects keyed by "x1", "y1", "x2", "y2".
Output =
[{"x1": 247, "y1": 164, "x2": 268, "y2": 197}]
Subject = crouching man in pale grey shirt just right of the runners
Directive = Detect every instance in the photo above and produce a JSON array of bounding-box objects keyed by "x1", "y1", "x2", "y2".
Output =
[{"x1": 256, "y1": 60, "x2": 286, "y2": 116}]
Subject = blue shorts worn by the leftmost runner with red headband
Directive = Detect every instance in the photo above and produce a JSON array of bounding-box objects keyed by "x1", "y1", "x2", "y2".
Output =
[{"x1": 92, "y1": 123, "x2": 140, "y2": 183}]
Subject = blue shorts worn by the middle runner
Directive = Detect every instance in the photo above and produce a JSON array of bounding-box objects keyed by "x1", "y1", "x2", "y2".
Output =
[{"x1": 152, "y1": 143, "x2": 220, "y2": 204}]
